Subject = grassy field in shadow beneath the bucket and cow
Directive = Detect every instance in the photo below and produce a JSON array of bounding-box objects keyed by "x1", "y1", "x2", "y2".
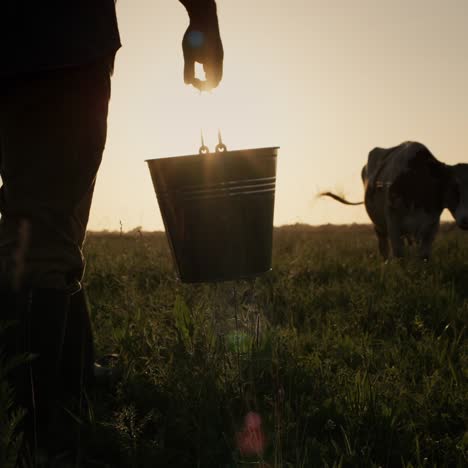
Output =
[{"x1": 0, "y1": 225, "x2": 468, "y2": 468}]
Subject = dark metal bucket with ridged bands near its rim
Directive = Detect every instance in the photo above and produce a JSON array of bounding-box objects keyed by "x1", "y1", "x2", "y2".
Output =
[{"x1": 147, "y1": 147, "x2": 278, "y2": 283}]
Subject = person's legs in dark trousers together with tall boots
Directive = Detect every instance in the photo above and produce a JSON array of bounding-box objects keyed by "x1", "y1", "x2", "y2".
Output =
[{"x1": 0, "y1": 59, "x2": 112, "y2": 444}]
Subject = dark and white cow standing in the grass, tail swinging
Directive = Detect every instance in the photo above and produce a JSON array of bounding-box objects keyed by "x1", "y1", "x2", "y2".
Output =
[{"x1": 319, "y1": 141, "x2": 468, "y2": 260}]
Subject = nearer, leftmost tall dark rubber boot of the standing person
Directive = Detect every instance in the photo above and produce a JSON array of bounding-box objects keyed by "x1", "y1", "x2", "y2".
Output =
[{"x1": 0, "y1": 289, "x2": 70, "y2": 451}]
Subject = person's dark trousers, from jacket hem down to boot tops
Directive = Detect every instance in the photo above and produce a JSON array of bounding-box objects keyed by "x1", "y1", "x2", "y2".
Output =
[{"x1": 0, "y1": 59, "x2": 112, "y2": 291}]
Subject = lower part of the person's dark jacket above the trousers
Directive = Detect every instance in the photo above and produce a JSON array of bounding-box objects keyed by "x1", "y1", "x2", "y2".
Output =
[{"x1": 0, "y1": 0, "x2": 121, "y2": 77}]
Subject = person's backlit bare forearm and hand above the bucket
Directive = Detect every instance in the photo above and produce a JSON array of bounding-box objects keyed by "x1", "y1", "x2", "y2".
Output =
[{"x1": 180, "y1": 0, "x2": 224, "y2": 91}]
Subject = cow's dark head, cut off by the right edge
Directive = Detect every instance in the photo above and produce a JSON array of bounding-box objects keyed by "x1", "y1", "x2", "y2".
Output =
[{"x1": 447, "y1": 164, "x2": 468, "y2": 230}]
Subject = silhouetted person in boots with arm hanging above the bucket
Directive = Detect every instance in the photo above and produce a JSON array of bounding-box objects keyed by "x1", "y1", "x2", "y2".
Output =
[{"x1": 0, "y1": 0, "x2": 223, "y2": 454}]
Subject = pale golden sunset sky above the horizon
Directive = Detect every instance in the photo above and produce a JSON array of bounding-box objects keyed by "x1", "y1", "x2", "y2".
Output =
[{"x1": 89, "y1": 0, "x2": 468, "y2": 230}]
